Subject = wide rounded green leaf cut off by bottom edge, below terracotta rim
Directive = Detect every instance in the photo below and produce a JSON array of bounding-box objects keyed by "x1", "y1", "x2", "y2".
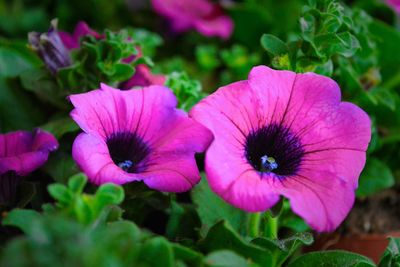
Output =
[{"x1": 288, "y1": 250, "x2": 375, "y2": 267}]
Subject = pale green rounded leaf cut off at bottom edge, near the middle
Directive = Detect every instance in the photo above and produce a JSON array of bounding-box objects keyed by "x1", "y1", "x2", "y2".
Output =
[{"x1": 205, "y1": 250, "x2": 255, "y2": 267}]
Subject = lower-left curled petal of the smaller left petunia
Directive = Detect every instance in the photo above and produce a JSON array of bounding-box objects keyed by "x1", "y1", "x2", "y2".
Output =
[{"x1": 72, "y1": 133, "x2": 142, "y2": 185}]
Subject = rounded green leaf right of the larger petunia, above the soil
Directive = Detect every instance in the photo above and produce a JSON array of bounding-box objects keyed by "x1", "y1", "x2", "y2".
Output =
[{"x1": 357, "y1": 157, "x2": 395, "y2": 197}]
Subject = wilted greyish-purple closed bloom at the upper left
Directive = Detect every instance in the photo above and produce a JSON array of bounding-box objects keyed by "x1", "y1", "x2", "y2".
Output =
[{"x1": 28, "y1": 20, "x2": 72, "y2": 74}]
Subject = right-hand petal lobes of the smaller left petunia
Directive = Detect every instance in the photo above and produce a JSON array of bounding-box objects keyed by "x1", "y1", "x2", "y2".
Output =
[{"x1": 141, "y1": 110, "x2": 213, "y2": 192}]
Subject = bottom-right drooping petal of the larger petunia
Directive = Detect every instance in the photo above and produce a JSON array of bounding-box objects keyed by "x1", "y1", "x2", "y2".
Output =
[{"x1": 274, "y1": 170, "x2": 355, "y2": 232}]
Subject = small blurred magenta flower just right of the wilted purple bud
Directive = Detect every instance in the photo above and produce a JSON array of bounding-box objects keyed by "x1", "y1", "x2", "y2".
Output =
[{"x1": 59, "y1": 21, "x2": 104, "y2": 50}]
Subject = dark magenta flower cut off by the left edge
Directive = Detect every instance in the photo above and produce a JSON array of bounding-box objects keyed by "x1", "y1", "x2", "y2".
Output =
[{"x1": 0, "y1": 129, "x2": 58, "y2": 204}]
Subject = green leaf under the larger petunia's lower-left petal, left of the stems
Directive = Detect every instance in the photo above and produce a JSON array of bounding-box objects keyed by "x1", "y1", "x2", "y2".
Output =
[{"x1": 191, "y1": 177, "x2": 247, "y2": 235}]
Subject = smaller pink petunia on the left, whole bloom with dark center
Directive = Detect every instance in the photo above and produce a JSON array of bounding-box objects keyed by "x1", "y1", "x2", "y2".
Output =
[{"x1": 70, "y1": 84, "x2": 212, "y2": 192}]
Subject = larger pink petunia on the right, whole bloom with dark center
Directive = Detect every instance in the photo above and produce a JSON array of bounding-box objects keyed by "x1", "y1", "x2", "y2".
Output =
[{"x1": 190, "y1": 66, "x2": 371, "y2": 232}]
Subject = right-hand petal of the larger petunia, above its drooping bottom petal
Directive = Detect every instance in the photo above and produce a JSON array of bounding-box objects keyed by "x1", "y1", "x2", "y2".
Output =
[{"x1": 300, "y1": 102, "x2": 371, "y2": 189}]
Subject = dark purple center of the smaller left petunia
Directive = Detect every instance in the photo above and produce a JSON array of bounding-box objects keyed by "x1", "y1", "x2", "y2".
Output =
[{"x1": 107, "y1": 132, "x2": 149, "y2": 173}]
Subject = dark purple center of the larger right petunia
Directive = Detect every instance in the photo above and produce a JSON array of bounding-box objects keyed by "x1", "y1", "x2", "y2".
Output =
[{"x1": 245, "y1": 124, "x2": 304, "y2": 176}]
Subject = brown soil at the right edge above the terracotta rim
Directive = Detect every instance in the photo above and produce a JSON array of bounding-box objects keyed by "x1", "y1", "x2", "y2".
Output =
[{"x1": 339, "y1": 188, "x2": 400, "y2": 234}]
